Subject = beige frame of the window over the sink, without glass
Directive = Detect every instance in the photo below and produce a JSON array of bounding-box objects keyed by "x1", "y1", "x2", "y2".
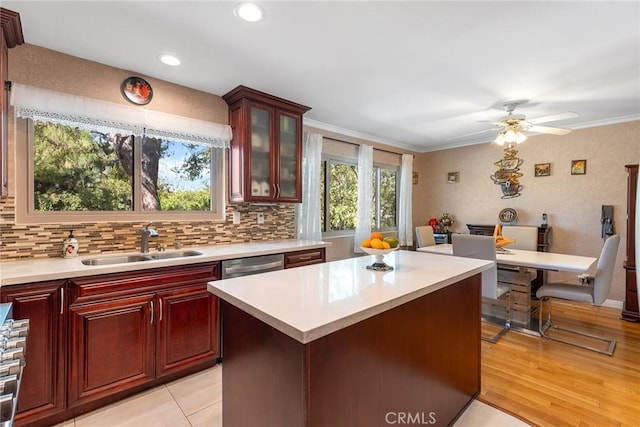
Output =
[{"x1": 14, "y1": 118, "x2": 226, "y2": 224}]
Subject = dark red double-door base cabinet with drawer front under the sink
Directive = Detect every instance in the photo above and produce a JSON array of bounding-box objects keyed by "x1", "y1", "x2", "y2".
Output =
[{"x1": 69, "y1": 262, "x2": 220, "y2": 407}]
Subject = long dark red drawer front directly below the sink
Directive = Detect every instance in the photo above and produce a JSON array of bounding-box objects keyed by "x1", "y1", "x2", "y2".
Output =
[{"x1": 69, "y1": 262, "x2": 220, "y2": 304}]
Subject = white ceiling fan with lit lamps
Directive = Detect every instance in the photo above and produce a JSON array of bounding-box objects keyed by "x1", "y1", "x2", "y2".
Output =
[{"x1": 456, "y1": 101, "x2": 578, "y2": 145}]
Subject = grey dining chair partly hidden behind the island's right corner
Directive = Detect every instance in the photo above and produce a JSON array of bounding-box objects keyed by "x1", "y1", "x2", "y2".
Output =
[{"x1": 451, "y1": 234, "x2": 511, "y2": 344}]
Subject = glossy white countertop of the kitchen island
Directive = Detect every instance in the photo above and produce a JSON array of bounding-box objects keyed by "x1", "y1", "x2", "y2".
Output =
[{"x1": 209, "y1": 250, "x2": 493, "y2": 343}]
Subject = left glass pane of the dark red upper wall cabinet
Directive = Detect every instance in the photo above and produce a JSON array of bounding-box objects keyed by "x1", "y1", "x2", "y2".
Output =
[{"x1": 248, "y1": 103, "x2": 276, "y2": 200}]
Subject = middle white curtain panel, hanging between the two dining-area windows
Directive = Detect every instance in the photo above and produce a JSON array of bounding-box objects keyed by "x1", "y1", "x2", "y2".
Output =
[{"x1": 353, "y1": 144, "x2": 373, "y2": 253}]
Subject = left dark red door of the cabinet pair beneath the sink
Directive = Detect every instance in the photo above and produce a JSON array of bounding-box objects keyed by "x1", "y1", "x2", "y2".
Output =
[{"x1": 69, "y1": 294, "x2": 155, "y2": 407}]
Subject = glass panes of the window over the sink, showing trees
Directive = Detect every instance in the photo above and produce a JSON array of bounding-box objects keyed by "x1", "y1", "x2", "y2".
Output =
[{"x1": 29, "y1": 121, "x2": 223, "y2": 222}]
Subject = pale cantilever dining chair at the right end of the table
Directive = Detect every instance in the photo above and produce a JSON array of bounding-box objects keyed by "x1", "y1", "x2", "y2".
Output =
[{"x1": 536, "y1": 235, "x2": 620, "y2": 356}]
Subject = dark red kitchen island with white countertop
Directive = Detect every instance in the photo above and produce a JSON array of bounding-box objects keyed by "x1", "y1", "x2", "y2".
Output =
[{"x1": 208, "y1": 251, "x2": 492, "y2": 426}]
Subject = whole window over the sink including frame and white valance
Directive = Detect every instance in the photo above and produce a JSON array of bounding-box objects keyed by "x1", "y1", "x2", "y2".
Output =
[{"x1": 12, "y1": 85, "x2": 231, "y2": 223}]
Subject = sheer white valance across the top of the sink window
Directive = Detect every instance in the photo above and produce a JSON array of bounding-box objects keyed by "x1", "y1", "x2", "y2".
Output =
[{"x1": 10, "y1": 83, "x2": 232, "y2": 147}]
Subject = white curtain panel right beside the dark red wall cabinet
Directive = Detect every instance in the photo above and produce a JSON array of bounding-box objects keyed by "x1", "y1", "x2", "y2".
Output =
[{"x1": 298, "y1": 131, "x2": 322, "y2": 241}]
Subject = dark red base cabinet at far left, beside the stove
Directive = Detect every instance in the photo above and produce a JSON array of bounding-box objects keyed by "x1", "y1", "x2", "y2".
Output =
[{"x1": 1, "y1": 281, "x2": 66, "y2": 424}]
